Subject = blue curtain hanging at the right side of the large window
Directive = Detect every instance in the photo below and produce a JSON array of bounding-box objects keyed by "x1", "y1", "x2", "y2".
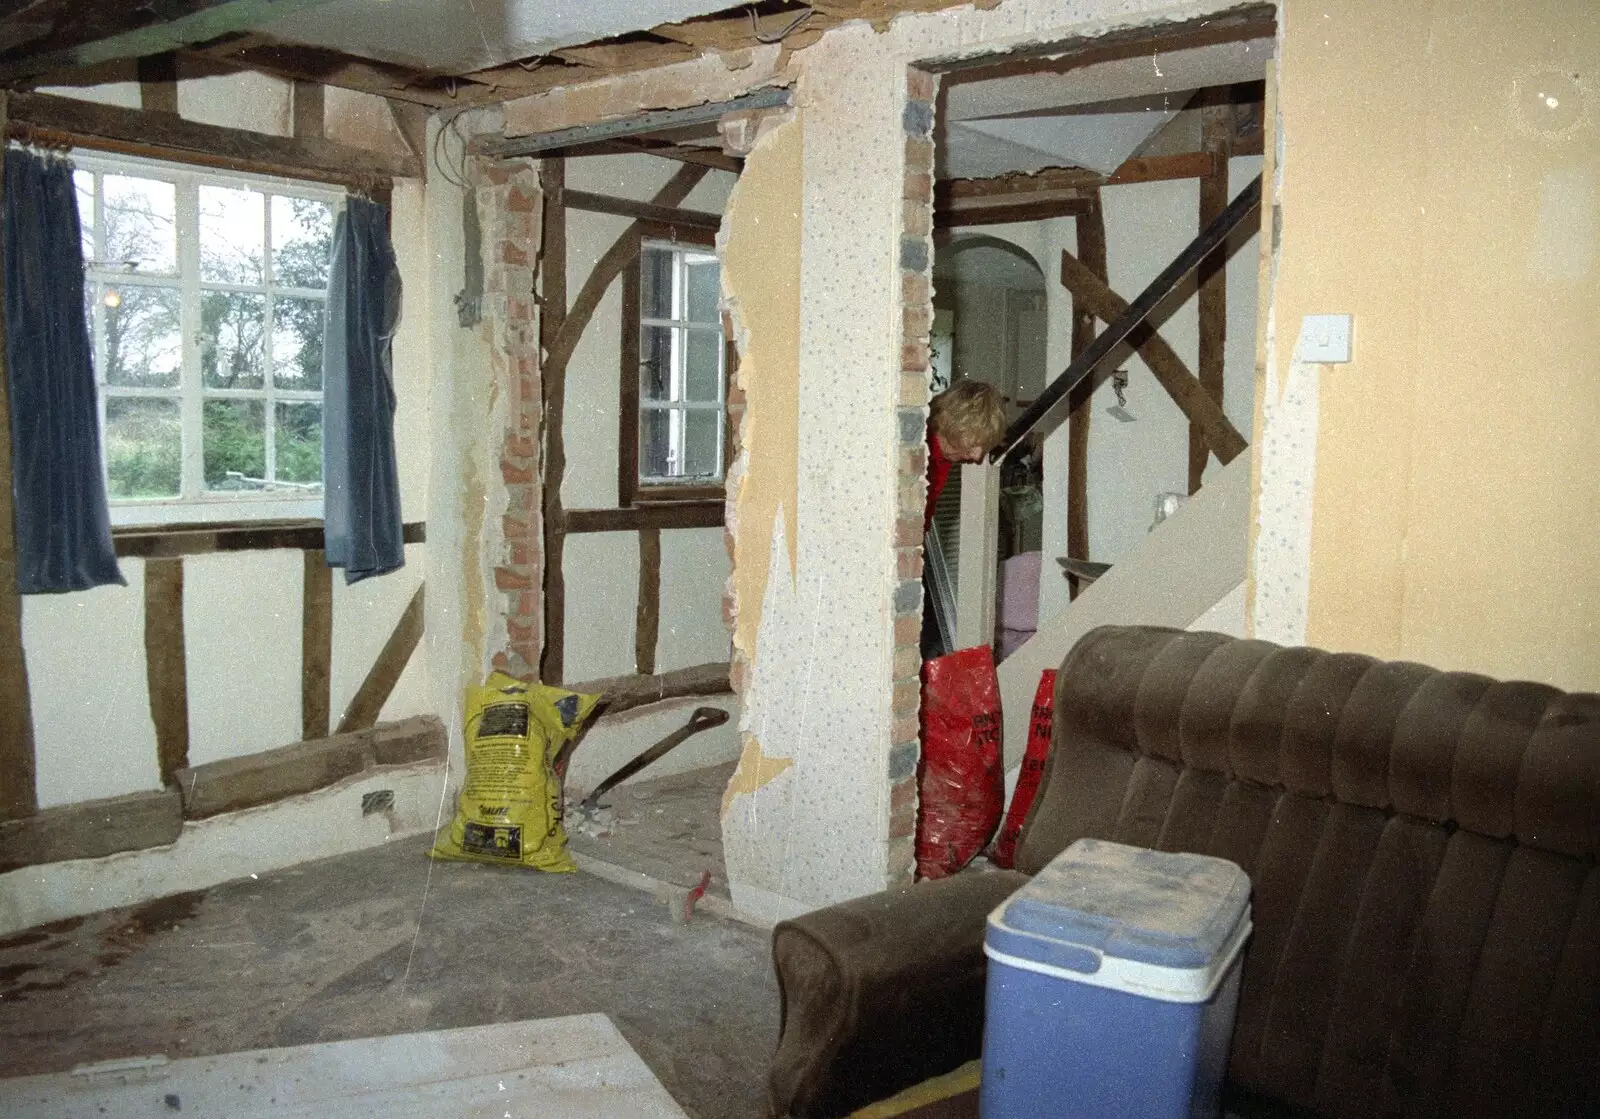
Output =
[{"x1": 322, "y1": 199, "x2": 405, "y2": 583}]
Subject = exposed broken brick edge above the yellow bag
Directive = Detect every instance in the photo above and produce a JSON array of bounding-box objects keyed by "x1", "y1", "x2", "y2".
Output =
[{"x1": 472, "y1": 160, "x2": 542, "y2": 679}]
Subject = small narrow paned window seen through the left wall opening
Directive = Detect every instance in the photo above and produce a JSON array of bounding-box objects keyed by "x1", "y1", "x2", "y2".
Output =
[{"x1": 624, "y1": 240, "x2": 728, "y2": 504}]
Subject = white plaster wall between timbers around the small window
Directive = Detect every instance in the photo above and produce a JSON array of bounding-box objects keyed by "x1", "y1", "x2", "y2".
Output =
[{"x1": 562, "y1": 155, "x2": 734, "y2": 688}]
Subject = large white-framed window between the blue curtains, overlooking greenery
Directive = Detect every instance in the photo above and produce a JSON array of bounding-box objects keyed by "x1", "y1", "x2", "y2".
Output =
[{"x1": 75, "y1": 152, "x2": 342, "y2": 523}]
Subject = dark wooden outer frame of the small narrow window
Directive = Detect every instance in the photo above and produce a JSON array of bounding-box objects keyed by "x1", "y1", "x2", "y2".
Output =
[{"x1": 618, "y1": 221, "x2": 736, "y2": 507}]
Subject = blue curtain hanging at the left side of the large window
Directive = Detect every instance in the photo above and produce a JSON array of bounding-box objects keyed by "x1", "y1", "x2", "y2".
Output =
[{"x1": 3, "y1": 149, "x2": 123, "y2": 594}]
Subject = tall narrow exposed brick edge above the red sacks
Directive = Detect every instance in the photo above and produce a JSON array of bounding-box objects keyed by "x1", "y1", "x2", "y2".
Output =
[{"x1": 888, "y1": 69, "x2": 938, "y2": 885}]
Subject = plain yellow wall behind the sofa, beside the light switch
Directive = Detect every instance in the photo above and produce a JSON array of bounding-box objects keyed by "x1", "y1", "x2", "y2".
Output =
[{"x1": 1275, "y1": 0, "x2": 1600, "y2": 690}]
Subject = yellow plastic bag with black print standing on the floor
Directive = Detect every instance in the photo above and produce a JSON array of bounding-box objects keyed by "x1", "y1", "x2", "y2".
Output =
[{"x1": 429, "y1": 672, "x2": 600, "y2": 874}]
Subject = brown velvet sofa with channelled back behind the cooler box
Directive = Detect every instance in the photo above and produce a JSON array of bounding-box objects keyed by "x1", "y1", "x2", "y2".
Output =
[{"x1": 770, "y1": 628, "x2": 1600, "y2": 1119}]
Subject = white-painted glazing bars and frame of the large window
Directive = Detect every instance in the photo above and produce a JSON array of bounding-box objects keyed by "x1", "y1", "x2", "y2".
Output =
[{"x1": 72, "y1": 147, "x2": 349, "y2": 528}]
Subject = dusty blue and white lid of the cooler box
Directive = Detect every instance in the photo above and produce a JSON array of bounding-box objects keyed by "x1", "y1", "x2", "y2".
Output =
[{"x1": 984, "y1": 839, "x2": 1250, "y2": 1002}]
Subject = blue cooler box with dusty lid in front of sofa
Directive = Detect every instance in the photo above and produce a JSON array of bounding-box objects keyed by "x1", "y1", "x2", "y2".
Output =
[{"x1": 981, "y1": 839, "x2": 1250, "y2": 1119}]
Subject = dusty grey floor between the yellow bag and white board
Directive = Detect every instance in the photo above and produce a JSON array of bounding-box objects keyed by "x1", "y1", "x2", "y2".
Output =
[{"x1": 0, "y1": 790, "x2": 778, "y2": 1119}]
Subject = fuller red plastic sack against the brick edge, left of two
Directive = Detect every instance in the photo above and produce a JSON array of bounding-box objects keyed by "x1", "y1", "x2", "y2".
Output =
[{"x1": 917, "y1": 645, "x2": 1005, "y2": 879}]
